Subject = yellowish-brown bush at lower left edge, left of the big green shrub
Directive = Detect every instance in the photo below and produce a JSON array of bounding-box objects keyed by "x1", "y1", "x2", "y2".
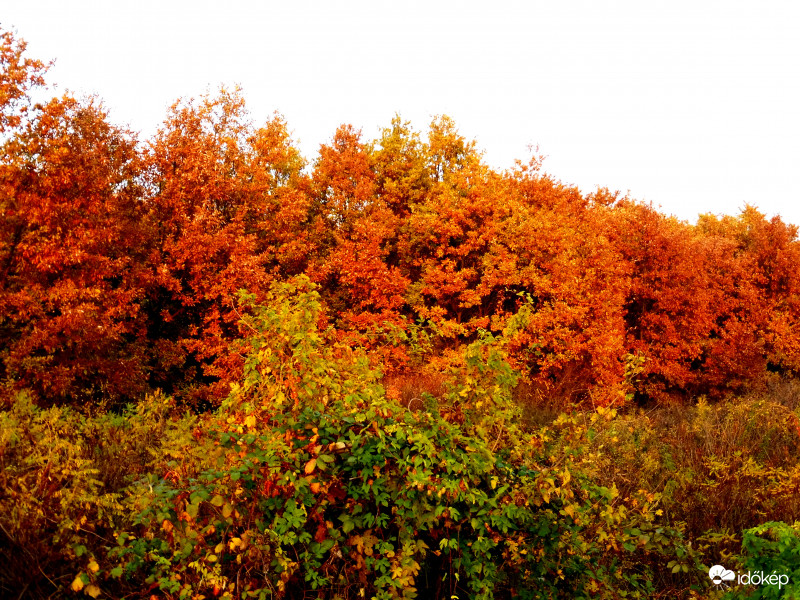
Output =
[{"x1": 0, "y1": 394, "x2": 204, "y2": 598}]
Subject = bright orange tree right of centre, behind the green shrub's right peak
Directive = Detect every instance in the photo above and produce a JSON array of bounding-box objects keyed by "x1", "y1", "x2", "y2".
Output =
[{"x1": 496, "y1": 168, "x2": 628, "y2": 405}]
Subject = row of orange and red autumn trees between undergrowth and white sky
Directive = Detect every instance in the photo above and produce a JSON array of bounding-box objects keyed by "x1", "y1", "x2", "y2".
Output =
[{"x1": 0, "y1": 33, "x2": 800, "y2": 408}]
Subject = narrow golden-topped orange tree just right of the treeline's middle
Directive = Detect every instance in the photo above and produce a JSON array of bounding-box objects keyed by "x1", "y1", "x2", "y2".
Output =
[{"x1": 397, "y1": 117, "x2": 494, "y2": 339}]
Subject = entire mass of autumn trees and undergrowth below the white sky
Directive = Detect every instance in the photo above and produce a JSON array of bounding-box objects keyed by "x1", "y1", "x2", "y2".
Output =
[{"x1": 0, "y1": 31, "x2": 800, "y2": 600}]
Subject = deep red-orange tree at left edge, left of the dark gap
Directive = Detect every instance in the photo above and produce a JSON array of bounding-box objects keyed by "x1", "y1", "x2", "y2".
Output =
[{"x1": 0, "y1": 97, "x2": 147, "y2": 403}]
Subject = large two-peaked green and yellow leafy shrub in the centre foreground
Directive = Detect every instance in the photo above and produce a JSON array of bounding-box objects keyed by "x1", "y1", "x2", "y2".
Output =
[{"x1": 95, "y1": 278, "x2": 692, "y2": 599}]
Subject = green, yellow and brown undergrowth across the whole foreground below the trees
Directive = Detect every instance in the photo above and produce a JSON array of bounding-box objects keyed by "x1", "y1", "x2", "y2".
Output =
[{"x1": 0, "y1": 278, "x2": 800, "y2": 599}]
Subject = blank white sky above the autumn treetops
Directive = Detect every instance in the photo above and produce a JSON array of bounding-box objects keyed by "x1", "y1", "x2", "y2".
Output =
[{"x1": 0, "y1": 0, "x2": 800, "y2": 224}]
